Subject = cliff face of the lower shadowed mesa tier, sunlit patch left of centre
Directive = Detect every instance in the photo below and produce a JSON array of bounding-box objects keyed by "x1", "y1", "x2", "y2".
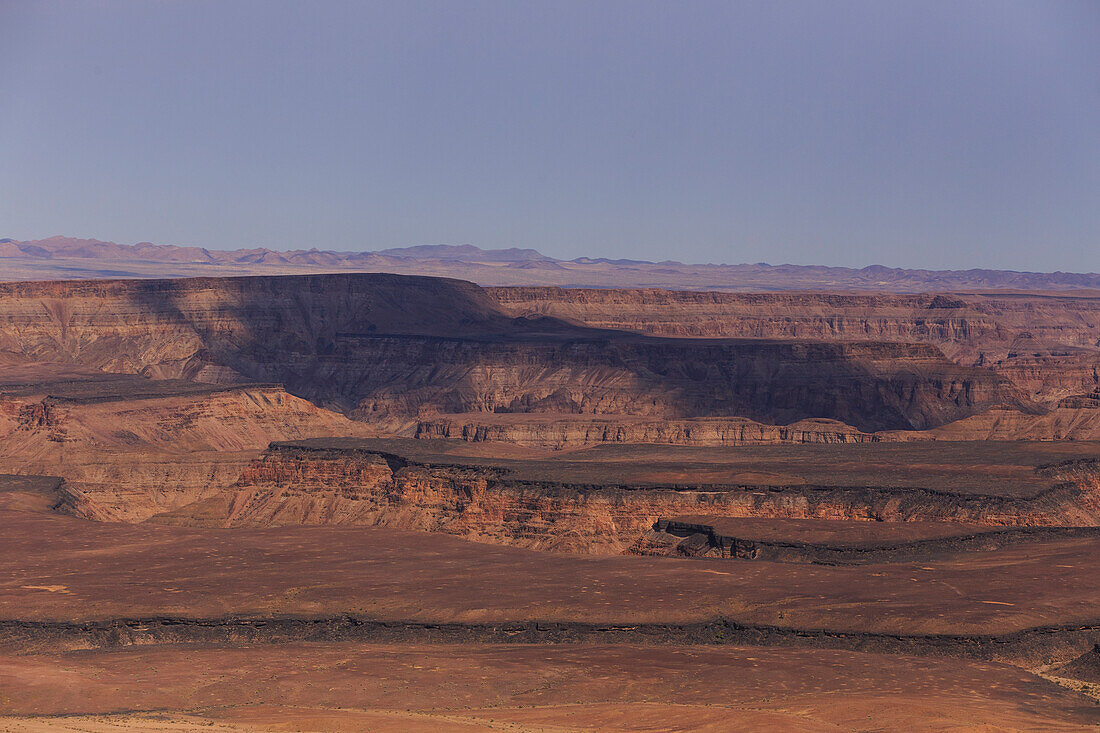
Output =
[{"x1": 343, "y1": 336, "x2": 1029, "y2": 429}]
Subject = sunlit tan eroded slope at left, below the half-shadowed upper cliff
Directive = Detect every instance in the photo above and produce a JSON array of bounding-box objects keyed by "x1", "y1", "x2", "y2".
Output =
[{"x1": 0, "y1": 378, "x2": 378, "y2": 521}]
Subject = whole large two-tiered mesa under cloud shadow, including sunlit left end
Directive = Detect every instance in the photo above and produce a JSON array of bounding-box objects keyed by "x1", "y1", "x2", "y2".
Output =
[{"x1": 0, "y1": 274, "x2": 1037, "y2": 430}]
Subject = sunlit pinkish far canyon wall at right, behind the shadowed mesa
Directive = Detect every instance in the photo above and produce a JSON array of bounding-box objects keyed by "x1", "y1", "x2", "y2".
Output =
[{"x1": 488, "y1": 287, "x2": 1100, "y2": 404}]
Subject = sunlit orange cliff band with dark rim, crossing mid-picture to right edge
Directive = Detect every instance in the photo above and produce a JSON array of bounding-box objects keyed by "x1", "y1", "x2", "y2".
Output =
[{"x1": 154, "y1": 439, "x2": 1100, "y2": 554}]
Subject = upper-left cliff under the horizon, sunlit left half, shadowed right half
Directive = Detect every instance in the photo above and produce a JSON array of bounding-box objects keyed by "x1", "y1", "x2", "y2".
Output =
[{"x1": 0, "y1": 275, "x2": 510, "y2": 379}]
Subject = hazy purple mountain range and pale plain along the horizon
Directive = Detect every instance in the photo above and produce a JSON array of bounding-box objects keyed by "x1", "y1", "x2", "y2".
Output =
[{"x1": 0, "y1": 237, "x2": 1100, "y2": 293}]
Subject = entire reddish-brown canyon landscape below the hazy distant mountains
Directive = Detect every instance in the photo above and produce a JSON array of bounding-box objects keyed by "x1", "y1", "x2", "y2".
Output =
[{"x1": 0, "y1": 273, "x2": 1100, "y2": 732}]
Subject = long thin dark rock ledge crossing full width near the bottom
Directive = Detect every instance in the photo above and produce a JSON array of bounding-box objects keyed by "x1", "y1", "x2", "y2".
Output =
[{"x1": 0, "y1": 614, "x2": 1100, "y2": 667}]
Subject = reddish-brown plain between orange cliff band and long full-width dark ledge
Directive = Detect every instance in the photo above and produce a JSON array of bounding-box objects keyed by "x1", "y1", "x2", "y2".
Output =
[{"x1": 0, "y1": 497, "x2": 1100, "y2": 634}]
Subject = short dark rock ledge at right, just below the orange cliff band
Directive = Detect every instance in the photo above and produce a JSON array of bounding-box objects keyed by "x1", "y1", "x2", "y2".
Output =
[{"x1": 653, "y1": 519, "x2": 1100, "y2": 565}]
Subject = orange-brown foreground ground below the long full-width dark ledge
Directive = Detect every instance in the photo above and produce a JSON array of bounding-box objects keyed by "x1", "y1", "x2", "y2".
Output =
[{"x1": 0, "y1": 644, "x2": 1100, "y2": 733}]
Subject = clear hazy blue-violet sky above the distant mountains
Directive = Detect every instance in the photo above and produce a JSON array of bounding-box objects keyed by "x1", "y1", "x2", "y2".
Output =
[{"x1": 0, "y1": 0, "x2": 1100, "y2": 272}]
